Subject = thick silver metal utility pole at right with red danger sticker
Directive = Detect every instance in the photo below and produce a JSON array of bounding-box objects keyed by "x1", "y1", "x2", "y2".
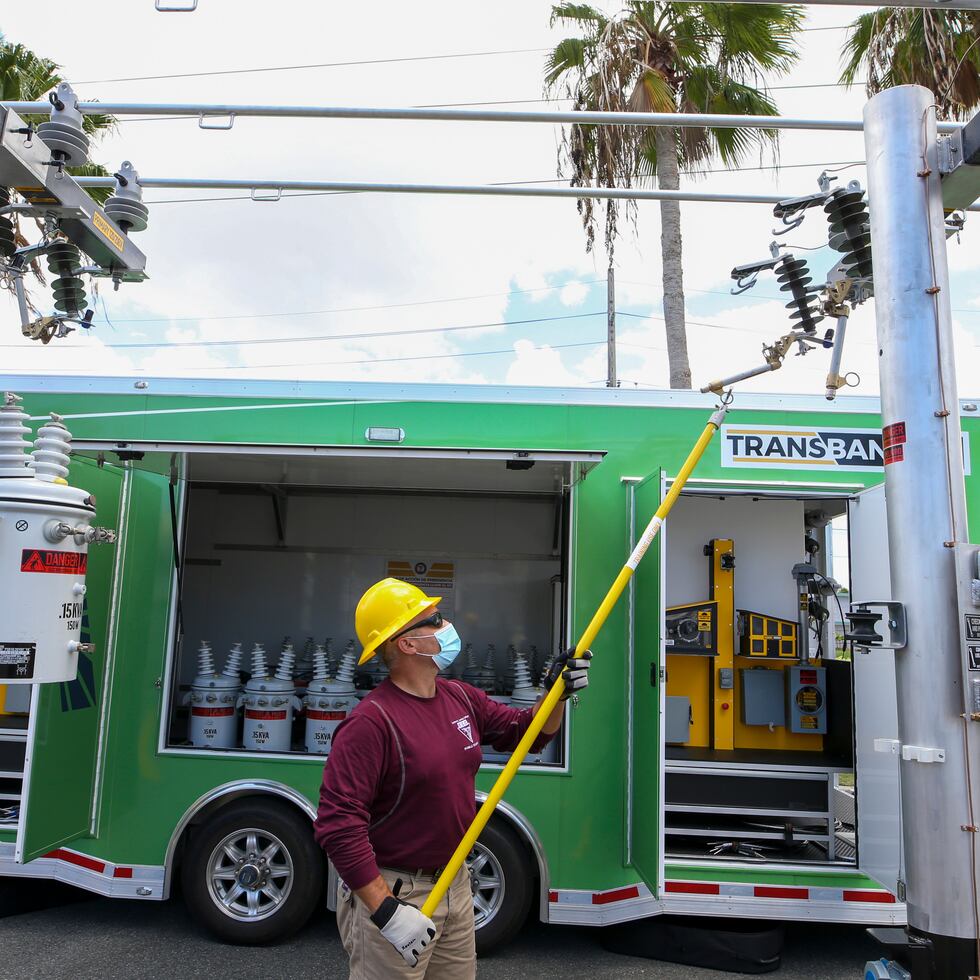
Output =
[{"x1": 864, "y1": 85, "x2": 980, "y2": 980}]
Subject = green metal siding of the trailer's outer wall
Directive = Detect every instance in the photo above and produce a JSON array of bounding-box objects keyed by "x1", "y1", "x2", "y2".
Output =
[{"x1": 13, "y1": 395, "x2": 980, "y2": 890}]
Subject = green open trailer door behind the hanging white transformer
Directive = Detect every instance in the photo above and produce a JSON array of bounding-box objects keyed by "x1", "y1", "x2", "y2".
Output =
[{"x1": 14, "y1": 458, "x2": 129, "y2": 863}]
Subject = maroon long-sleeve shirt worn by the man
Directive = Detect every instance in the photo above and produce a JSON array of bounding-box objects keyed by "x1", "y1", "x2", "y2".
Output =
[{"x1": 314, "y1": 678, "x2": 550, "y2": 889}]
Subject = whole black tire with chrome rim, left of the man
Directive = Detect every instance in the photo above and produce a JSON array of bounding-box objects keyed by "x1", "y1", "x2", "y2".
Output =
[{"x1": 181, "y1": 798, "x2": 324, "y2": 946}]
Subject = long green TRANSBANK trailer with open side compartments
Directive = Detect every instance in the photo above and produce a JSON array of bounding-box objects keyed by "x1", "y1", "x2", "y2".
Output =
[{"x1": 0, "y1": 376, "x2": 964, "y2": 949}]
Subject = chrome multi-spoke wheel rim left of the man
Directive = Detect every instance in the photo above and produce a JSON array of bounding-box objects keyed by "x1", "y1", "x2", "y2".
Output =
[{"x1": 207, "y1": 827, "x2": 295, "y2": 922}]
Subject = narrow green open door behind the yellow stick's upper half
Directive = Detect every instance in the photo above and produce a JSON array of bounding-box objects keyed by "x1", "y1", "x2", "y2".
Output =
[{"x1": 627, "y1": 470, "x2": 669, "y2": 897}]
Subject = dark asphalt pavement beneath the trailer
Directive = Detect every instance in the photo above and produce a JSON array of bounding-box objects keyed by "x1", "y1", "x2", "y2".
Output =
[{"x1": 0, "y1": 882, "x2": 877, "y2": 980}]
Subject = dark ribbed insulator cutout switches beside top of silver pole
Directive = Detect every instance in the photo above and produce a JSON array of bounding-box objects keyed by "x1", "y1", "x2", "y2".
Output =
[{"x1": 701, "y1": 173, "x2": 873, "y2": 401}]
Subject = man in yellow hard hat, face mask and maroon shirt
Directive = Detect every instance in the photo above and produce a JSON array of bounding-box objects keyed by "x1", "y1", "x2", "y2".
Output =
[{"x1": 314, "y1": 578, "x2": 592, "y2": 980}]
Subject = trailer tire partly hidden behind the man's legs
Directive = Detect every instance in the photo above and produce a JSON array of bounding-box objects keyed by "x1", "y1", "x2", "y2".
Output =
[{"x1": 466, "y1": 820, "x2": 534, "y2": 956}]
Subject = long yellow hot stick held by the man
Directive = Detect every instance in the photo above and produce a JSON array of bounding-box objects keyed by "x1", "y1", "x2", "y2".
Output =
[{"x1": 422, "y1": 404, "x2": 728, "y2": 917}]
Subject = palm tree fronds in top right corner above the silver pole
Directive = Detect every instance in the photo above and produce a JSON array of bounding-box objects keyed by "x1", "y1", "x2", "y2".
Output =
[{"x1": 841, "y1": 7, "x2": 980, "y2": 119}]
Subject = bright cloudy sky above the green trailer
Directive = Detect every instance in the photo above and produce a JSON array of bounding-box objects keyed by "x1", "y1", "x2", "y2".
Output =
[{"x1": 0, "y1": 0, "x2": 980, "y2": 396}]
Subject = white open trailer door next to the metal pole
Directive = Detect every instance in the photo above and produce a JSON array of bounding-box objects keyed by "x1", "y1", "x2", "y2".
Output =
[{"x1": 848, "y1": 484, "x2": 902, "y2": 893}]
